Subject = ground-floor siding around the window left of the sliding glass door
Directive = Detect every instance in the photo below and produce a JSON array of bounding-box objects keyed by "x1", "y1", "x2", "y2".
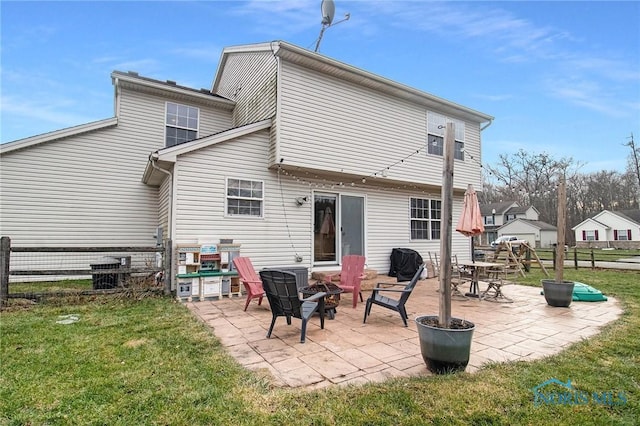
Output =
[{"x1": 169, "y1": 130, "x2": 311, "y2": 268}]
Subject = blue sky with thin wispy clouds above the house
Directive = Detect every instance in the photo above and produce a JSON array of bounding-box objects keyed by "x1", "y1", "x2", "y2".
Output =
[{"x1": 0, "y1": 0, "x2": 640, "y2": 173}]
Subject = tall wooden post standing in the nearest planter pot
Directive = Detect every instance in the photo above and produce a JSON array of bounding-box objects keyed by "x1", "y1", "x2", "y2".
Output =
[{"x1": 438, "y1": 123, "x2": 455, "y2": 328}]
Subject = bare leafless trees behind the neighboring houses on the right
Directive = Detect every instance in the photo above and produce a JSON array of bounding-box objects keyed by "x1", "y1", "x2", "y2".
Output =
[{"x1": 478, "y1": 135, "x2": 640, "y2": 245}]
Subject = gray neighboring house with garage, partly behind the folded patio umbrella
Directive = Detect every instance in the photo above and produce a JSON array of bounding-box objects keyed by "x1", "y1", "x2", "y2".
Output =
[{"x1": 480, "y1": 201, "x2": 540, "y2": 245}]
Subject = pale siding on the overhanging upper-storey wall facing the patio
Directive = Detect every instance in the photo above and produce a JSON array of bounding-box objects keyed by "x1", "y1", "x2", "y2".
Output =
[{"x1": 272, "y1": 62, "x2": 481, "y2": 188}]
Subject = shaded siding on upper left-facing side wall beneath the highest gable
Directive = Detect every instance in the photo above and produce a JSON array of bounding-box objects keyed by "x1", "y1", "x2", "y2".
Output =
[{"x1": 214, "y1": 52, "x2": 277, "y2": 127}]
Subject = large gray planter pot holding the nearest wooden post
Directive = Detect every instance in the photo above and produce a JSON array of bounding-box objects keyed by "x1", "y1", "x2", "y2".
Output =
[{"x1": 415, "y1": 315, "x2": 475, "y2": 374}]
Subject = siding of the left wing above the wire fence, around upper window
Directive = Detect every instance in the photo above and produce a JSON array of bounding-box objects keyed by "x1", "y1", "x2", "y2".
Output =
[{"x1": 0, "y1": 83, "x2": 231, "y2": 246}]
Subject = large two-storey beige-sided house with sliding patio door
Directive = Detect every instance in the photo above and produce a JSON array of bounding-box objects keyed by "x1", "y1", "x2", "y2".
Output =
[{"x1": 0, "y1": 41, "x2": 492, "y2": 290}]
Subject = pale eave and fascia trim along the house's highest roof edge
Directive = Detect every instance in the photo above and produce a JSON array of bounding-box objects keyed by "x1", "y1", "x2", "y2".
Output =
[{"x1": 211, "y1": 41, "x2": 493, "y2": 124}]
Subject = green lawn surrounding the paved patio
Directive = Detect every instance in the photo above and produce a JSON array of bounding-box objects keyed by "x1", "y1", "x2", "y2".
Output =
[{"x1": 0, "y1": 269, "x2": 640, "y2": 425}]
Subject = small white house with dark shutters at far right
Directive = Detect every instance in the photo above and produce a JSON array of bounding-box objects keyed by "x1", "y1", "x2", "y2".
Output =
[{"x1": 571, "y1": 209, "x2": 640, "y2": 249}]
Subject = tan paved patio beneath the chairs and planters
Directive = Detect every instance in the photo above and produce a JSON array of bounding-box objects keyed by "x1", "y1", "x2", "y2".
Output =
[{"x1": 187, "y1": 276, "x2": 622, "y2": 389}]
